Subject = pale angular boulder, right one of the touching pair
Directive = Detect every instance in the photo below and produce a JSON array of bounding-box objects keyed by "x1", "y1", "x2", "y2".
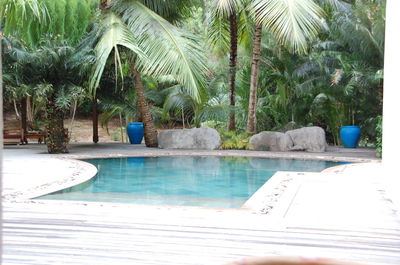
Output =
[{"x1": 286, "y1": 126, "x2": 327, "y2": 152}]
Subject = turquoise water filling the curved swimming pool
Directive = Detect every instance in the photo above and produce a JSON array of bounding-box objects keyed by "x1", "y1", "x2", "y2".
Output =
[{"x1": 39, "y1": 156, "x2": 338, "y2": 208}]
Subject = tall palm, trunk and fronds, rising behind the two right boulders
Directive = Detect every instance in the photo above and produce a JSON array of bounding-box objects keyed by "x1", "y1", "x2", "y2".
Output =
[{"x1": 246, "y1": 0, "x2": 323, "y2": 134}]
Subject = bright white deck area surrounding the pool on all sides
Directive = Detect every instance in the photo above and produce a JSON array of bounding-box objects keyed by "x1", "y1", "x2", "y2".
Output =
[{"x1": 3, "y1": 144, "x2": 400, "y2": 264}]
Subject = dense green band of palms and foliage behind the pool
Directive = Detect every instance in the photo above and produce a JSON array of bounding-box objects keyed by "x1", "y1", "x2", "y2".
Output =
[{"x1": 0, "y1": 0, "x2": 385, "y2": 152}]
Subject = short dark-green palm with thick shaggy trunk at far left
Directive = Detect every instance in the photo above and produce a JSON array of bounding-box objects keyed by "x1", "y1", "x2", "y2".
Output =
[{"x1": 5, "y1": 40, "x2": 84, "y2": 154}]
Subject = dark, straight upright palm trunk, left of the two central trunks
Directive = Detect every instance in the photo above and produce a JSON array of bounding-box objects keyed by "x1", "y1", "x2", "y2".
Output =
[{"x1": 228, "y1": 12, "x2": 238, "y2": 131}]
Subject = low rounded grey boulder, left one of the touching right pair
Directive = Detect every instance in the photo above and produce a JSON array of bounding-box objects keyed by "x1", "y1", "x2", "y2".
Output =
[{"x1": 250, "y1": 132, "x2": 293, "y2": 151}]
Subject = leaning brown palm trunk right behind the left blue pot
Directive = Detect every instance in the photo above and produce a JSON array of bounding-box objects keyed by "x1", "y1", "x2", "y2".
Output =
[{"x1": 130, "y1": 60, "x2": 158, "y2": 147}]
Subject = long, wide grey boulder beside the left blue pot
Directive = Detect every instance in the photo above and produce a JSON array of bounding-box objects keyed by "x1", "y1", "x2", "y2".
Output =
[{"x1": 158, "y1": 127, "x2": 221, "y2": 150}]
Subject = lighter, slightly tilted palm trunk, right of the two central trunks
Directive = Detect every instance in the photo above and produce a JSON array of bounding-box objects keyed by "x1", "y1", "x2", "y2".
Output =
[{"x1": 246, "y1": 24, "x2": 262, "y2": 134}]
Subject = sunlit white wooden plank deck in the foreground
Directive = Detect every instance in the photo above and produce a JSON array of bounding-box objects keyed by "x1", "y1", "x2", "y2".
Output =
[{"x1": 3, "y1": 200, "x2": 400, "y2": 265}]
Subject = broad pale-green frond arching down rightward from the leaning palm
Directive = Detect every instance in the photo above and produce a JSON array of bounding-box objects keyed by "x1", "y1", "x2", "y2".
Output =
[{"x1": 112, "y1": 0, "x2": 207, "y2": 100}]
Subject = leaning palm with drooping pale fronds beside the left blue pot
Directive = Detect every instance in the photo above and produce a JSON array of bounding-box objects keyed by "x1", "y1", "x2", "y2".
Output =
[{"x1": 91, "y1": 0, "x2": 206, "y2": 147}]
